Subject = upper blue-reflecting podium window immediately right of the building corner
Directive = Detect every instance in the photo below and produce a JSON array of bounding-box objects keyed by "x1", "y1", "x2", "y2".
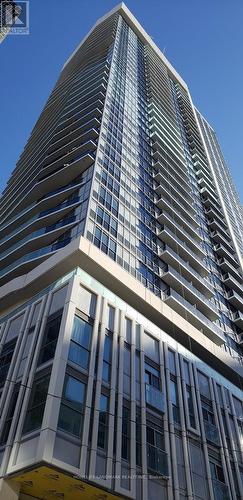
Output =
[{"x1": 68, "y1": 316, "x2": 92, "y2": 370}]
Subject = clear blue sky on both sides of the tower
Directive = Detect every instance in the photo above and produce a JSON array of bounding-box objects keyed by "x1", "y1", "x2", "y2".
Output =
[{"x1": 0, "y1": 0, "x2": 243, "y2": 200}]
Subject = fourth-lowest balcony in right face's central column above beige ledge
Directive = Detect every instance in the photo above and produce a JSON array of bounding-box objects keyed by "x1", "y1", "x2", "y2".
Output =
[{"x1": 158, "y1": 226, "x2": 208, "y2": 276}]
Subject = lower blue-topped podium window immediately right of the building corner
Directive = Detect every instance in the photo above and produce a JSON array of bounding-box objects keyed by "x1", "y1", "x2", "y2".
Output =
[{"x1": 58, "y1": 374, "x2": 85, "y2": 437}]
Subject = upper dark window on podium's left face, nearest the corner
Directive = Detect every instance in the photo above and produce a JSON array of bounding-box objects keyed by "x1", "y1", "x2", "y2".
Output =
[{"x1": 38, "y1": 314, "x2": 62, "y2": 366}]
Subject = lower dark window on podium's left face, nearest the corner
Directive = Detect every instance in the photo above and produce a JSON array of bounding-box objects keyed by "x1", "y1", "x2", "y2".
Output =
[{"x1": 23, "y1": 375, "x2": 50, "y2": 434}]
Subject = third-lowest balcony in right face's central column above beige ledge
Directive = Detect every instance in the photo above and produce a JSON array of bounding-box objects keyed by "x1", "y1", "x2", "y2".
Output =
[{"x1": 160, "y1": 245, "x2": 214, "y2": 298}]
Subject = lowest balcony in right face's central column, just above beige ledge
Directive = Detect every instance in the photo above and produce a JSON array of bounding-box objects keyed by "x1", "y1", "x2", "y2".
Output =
[{"x1": 163, "y1": 288, "x2": 224, "y2": 345}]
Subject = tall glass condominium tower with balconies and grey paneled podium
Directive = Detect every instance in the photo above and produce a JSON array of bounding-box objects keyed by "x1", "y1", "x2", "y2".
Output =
[{"x1": 0, "y1": 4, "x2": 243, "y2": 500}]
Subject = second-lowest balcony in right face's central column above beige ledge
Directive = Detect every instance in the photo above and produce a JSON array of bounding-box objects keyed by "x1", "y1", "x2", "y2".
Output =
[{"x1": 161, "y1": 264, "x2": 219, "y2": 321}]
